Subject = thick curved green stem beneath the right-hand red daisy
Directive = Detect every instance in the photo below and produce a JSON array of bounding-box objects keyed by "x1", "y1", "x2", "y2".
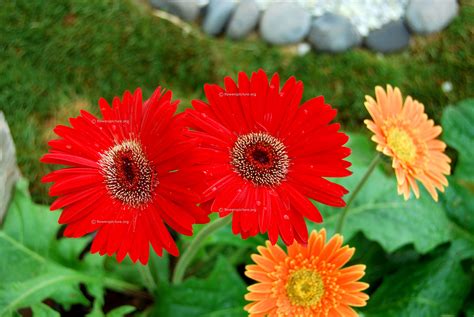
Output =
[{"x1": 172, "y1": 216, "x2": 232, "y2": 284}]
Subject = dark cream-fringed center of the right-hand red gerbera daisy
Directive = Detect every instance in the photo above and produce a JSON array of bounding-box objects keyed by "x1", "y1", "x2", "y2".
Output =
[{"x1": 230, "y1": 132, "x2": 289, "y2": 185}]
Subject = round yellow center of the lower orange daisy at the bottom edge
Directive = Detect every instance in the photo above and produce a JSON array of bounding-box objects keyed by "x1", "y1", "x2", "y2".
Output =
[{"x1": 286, "y1": 269, "x2": 324, "y2": 307}]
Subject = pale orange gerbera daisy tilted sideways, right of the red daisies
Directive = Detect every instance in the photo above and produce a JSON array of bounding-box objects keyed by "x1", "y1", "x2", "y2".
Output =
[{"x1": 364, "y1": 85, "x2": 451, "y2": 201}]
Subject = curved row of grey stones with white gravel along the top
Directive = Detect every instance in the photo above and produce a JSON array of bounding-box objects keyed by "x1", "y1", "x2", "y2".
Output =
[{"x1": 149, "y1": 0, "x2": 459, "y2": 53}]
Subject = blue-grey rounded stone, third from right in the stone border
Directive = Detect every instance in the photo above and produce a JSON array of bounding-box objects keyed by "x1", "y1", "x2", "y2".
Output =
[{"x1": 308, "y1": 13, "x2": 362, "y2": 52}]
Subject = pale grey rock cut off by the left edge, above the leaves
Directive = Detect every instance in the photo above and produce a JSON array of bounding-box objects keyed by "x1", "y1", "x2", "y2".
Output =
[{"x1": 0, "y1": 111, "x2": 20, "y2": 223}]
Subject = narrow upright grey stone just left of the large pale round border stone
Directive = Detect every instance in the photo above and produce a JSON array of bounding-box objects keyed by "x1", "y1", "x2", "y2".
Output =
[{"x1": 227, "y1": 0, "x2": 260, "y2": 40}]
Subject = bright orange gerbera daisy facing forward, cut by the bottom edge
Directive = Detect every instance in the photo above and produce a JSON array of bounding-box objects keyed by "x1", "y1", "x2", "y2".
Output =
[{"x1": 244, "y1": 229, "x2": 369, "y2": 317}]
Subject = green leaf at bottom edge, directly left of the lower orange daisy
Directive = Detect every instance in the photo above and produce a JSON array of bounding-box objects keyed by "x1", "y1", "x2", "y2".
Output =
[{"x1": 152, "y1": 257, "x2": 246, "y2": 317}]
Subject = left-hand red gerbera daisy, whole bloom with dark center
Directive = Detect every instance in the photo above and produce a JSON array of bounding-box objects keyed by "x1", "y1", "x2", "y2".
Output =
[{"x1": 41, "y1": 88, "x2": 208, "y2": 264}]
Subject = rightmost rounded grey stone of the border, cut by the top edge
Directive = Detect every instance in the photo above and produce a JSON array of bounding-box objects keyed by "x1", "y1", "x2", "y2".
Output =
[{"x1": 406, "y1": 0, "x2": 459, "y2": 34}]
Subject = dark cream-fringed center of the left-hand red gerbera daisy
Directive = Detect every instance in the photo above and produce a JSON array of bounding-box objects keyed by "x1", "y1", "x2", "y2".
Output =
[{"x1": 99, "y1": 140, "x2": 158, "y2": 208}]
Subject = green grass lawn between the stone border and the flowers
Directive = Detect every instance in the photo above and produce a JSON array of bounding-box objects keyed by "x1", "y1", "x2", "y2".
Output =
[{"x1": 0, "y1": 0, "x2": 474, "y2": 202}]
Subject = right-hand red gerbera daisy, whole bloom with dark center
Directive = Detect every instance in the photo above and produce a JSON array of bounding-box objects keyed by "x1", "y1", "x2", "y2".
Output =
[{"x1": 186, "y1": 70, "x2": 350, "y2": 245}]
